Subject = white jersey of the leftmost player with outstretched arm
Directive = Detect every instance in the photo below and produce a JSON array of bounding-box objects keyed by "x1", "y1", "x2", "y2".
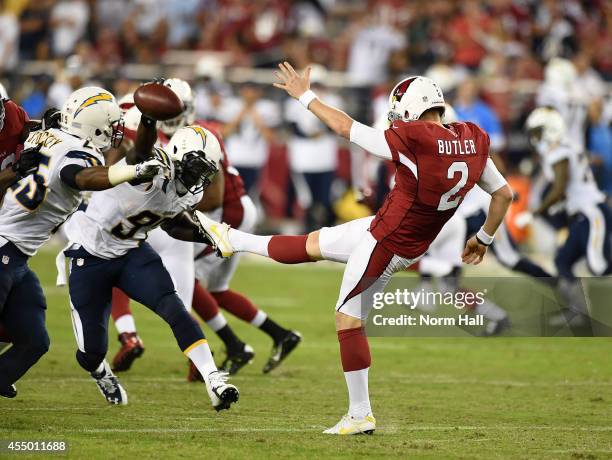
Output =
[{"x1": 0, "y1": 129, "x2": 104, "y2": 256}]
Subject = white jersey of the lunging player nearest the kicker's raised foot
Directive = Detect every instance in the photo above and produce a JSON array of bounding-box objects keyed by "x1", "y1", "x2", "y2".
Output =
[{"x1": 65, "y1": 149, "x2": 203, "y2": 259}]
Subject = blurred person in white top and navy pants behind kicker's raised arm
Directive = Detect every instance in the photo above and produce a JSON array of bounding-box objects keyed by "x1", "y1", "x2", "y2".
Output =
[{"x1": 285, "y1": 67, "x2": 342, "y2": 232}]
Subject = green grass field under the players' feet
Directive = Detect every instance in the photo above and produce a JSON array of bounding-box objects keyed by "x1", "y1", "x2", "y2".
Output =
[{"x1": 0, "y1": 253, "x2": 612, "y2": 459}]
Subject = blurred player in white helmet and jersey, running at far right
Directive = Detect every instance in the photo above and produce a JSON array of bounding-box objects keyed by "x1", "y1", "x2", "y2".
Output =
[{"x1": 516, "y1": 107, "x2": 612, "y2": 320}]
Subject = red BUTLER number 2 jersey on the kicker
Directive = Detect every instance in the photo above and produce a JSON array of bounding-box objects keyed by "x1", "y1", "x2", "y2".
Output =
[{"x1": 370, "y1": 121, "x2": 489, "y2": 259}]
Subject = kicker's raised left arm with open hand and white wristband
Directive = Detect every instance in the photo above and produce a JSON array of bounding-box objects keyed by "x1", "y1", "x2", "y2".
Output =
[{"x1": 274, "y1": 62, "x2": 391, "y2": 160}]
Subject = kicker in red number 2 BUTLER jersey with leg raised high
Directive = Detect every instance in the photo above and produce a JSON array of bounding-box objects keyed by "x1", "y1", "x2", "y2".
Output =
[{"x1": 197, "y1": 62, "x2": 512, "y2": 435}]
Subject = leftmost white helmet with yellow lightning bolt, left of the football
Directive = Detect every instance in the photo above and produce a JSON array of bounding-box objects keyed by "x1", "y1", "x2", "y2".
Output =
[{"x1": 60, "y1": 86, "x2": 123, "y2": 152}]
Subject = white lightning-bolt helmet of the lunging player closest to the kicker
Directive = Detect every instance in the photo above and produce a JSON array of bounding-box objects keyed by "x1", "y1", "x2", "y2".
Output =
[{"x1": 164, "y1": 125, "x2": 223, "y2": 194}]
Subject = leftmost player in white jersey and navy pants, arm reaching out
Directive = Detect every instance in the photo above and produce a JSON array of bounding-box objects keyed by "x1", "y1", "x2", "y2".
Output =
[{"x1": 0, "y1": 87, "x2": 162, "y2": 397}]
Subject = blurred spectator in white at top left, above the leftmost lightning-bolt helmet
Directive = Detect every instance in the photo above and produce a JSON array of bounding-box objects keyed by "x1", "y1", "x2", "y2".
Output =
[{"x1": 51, "y1": 0, "x2": 89, "y2": 57}]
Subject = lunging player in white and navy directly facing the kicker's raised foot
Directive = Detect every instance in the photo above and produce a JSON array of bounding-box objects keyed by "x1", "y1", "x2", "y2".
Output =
[{"x1": 65, "y1": 123, "x2": 239, "y2": 410}]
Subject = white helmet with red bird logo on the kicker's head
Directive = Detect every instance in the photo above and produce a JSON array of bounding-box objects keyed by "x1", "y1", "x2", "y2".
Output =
[{"x1": 388, "y1": 76, "x2": 446, "y2": 122}]
